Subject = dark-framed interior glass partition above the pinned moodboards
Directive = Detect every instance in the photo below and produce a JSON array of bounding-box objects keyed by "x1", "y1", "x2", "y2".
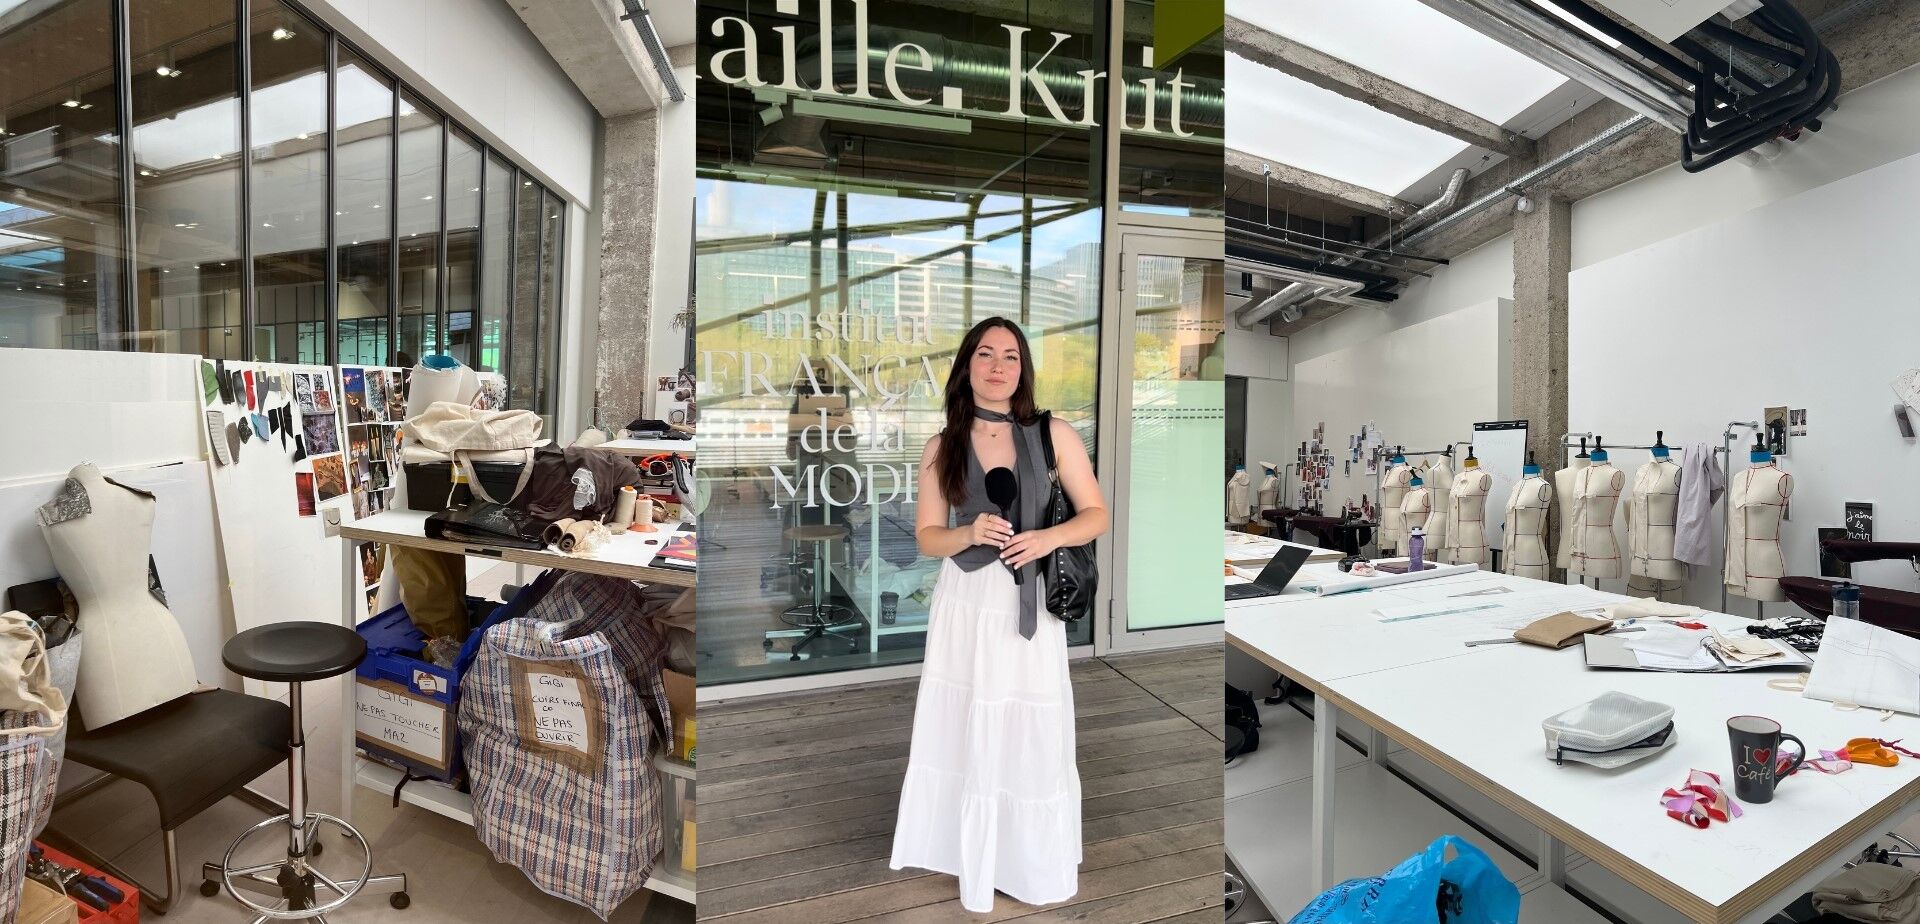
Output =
[{"x1": 0, "y1": 0, "x2": 566, "y2": 415}]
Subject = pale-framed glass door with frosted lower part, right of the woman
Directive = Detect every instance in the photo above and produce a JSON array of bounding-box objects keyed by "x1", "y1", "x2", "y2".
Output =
[{"x1": 1102, "y1": 231, "x2": 1227, "y2": 651}]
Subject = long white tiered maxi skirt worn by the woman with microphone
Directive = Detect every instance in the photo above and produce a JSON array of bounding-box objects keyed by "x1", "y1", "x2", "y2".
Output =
[{"x1": 891, "y1": 559, "x2": 1081, "y2": 912}]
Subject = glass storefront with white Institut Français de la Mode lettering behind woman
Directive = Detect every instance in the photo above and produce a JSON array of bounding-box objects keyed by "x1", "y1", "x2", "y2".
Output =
[{"x1": 695, "y1": 0, "x2": 1113, "y2": 684}]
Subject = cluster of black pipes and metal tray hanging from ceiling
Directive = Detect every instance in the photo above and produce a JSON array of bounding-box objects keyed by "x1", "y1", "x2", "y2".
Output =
[{"x1": 1421, "y1": 0, "x2": 1839, "y2": 171}]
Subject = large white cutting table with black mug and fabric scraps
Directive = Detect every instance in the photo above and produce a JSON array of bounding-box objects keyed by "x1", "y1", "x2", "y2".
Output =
[{"x1": 1227, "y1": 565, "x2": 1920, "y2": 924}]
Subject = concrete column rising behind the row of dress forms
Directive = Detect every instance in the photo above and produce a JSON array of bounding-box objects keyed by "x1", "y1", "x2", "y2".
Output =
[{"x1": 1511, "y1": 198, "x2": 1572, "y2": 580}]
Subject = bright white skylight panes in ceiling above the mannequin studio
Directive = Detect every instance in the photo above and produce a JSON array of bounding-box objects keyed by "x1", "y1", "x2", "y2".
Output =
[{"x1": 1227, "y1": 0, "x2": 1599, "y2": 202}]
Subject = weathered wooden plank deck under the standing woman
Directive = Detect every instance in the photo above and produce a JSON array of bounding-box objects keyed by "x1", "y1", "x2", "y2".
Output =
[{"x1": 697, "y1": 645, "x2": 1225, "y2": 924}]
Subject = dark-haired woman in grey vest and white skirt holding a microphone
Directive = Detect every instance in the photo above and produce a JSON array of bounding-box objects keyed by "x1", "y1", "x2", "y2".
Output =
[{"x1": 891, "y1": 317, "x2": 1108, "y2": 912}]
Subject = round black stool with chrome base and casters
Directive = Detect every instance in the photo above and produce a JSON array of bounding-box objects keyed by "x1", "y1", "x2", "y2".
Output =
[{"x1": 200, "y1": 620, "x2": 409, "y2": 924}]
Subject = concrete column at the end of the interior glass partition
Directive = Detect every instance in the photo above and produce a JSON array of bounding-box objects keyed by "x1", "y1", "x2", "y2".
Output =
[{"x1": 593, "y1": 111, "x2": 672, "y2": 428}]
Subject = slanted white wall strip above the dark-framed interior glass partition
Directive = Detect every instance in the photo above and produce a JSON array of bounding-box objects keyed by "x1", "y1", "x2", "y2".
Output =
[{"x1": 305, "y1": 0, "x2": 599, "y2": 204}]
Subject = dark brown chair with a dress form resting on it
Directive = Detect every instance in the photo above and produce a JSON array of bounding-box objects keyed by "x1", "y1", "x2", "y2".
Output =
[{"x1": 46, "y1": 690, "x2": 288, "y2": 914}]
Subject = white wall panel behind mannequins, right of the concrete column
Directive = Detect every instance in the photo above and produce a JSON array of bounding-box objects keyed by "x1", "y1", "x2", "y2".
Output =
[{"x1": 1569, "y1": 146, "x2": 1920, "y2": 611}]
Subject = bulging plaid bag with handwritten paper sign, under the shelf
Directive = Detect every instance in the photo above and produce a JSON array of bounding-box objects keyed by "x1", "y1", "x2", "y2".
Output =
[{"x1": 459, "y1": 574, "x2": 666, "y2": 920}]
